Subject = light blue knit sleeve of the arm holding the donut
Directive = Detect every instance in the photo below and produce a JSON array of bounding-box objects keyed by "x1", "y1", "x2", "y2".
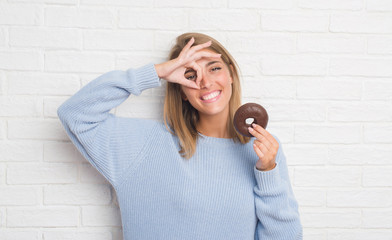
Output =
[{"x1": 254, "y1": 136, "x2": 302, "y2": 240}]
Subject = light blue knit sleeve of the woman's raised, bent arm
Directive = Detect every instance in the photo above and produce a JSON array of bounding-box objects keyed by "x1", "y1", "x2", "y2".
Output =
[{"x1": 57, "y1": 64, "x2": 160, "y2": 186}]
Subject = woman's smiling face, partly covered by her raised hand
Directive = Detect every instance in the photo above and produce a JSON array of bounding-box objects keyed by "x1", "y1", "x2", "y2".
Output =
[{"x1": 181, "y1": 50, "x2": 233, "y2": 117}]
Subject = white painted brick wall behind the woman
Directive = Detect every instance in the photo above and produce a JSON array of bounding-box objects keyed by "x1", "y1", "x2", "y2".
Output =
[{"x1": 0, "y1": 0, "x2": 392, "y2": 240}]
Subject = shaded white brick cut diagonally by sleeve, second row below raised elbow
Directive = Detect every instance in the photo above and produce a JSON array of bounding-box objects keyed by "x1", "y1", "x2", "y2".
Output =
[{"x1": 43, "y1": 142, "x2": 86, "y2": 162}]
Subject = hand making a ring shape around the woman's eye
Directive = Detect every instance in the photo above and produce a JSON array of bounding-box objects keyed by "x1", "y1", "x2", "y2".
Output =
[{"x1": 155, "y1": 38, "x2": 221, "y2": 89}]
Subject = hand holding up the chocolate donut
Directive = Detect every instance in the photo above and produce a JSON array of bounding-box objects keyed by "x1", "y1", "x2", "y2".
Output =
[{"x1": 249, "y1": 124, "x2": 279, "y2": 171}]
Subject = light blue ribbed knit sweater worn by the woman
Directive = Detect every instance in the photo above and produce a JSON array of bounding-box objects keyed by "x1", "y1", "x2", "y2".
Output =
[{"x1": 58, "y1": 64, "x2": 302, "y2": 240}]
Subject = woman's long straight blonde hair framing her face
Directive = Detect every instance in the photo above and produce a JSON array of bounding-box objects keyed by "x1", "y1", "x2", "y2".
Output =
[{"x1": 163, "y1": 33, "x2": 250, "y2": 159}]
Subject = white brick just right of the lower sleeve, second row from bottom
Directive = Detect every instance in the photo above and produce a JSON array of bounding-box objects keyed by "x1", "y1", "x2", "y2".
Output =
[{"x1": 301, "y1": 209, "x2": 361, "y2": 228}]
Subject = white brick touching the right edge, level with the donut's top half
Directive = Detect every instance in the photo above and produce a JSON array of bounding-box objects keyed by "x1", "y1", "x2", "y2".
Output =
[{"x1": 328, "y1": 102, "x2": 392, "y2": 122}]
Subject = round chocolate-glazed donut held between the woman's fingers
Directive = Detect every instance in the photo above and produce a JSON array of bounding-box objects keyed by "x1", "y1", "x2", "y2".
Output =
[{"x1": 234, "y1": 103, "x2": 268, "y2": 137}]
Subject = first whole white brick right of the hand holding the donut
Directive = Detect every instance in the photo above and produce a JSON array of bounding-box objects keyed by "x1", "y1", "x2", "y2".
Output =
[{"x1": 294, "y1": 124, "x2": 361, "y2": 144}]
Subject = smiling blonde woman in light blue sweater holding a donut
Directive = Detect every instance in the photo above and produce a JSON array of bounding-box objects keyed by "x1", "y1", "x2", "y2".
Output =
[{"x1": 58, "y1": 33, "x2": 302, "y2": 240}]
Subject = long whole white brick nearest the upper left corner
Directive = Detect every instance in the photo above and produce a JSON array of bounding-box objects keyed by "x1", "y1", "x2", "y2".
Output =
[{"x1": 9, "y1": 27, "x2": 82, "y2": 49}]
